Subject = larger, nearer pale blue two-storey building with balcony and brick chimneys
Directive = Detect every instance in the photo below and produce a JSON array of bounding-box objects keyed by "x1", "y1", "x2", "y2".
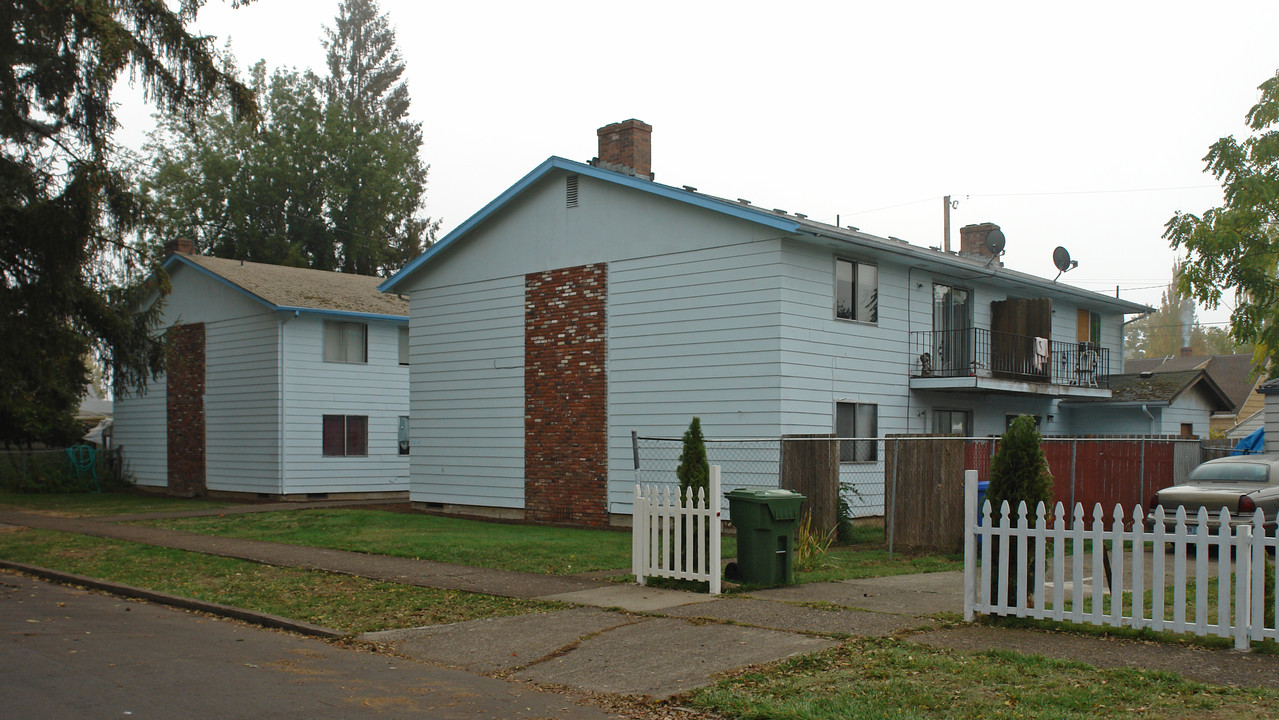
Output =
[{"x1": 381, "y1": 120, "x2": 1149, "y2": 524}]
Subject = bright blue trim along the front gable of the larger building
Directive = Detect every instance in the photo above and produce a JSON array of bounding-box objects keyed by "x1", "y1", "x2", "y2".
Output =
[{"x1": 377, "y1": 156, "x2": 799, "y2": 293}]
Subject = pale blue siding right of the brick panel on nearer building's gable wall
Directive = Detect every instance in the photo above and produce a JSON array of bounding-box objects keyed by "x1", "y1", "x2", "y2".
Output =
[{"x1": 608, "y1": 240, "x2": 781, "y2": 513}]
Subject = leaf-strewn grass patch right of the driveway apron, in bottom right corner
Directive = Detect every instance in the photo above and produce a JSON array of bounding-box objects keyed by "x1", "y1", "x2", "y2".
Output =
[{"x1": 687, "y1": 638, "x2": 1279, "y2": 720}]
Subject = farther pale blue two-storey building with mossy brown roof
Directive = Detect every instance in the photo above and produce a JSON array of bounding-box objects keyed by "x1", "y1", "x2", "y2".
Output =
[{"x1": 115, "y1": 243, "x2": 409, "y2": 497}]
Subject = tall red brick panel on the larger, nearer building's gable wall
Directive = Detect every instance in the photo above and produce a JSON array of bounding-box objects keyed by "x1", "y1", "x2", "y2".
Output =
[{"x1": 524, "y1": 263, "x2": 609, "y2": 526}]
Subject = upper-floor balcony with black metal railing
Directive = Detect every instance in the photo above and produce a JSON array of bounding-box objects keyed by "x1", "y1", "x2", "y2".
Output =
[{"x1": 911, "y1": 327, "x2": 1110, "y2": 398}]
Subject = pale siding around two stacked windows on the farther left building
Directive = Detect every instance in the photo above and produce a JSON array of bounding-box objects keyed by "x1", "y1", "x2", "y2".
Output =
[{"x1": 284, "y1": 316, "x2": 409, "y2": 495}]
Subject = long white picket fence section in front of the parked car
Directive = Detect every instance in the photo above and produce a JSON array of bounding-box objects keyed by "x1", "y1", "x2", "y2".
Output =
[{"x1": 964, "y1": 471, "x2": 1279, "y2": 650}]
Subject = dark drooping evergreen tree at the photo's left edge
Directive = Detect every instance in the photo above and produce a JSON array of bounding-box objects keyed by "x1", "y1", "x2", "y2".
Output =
[{"x1": 0, "y1": 0, "x2": 255, "y2": 445}]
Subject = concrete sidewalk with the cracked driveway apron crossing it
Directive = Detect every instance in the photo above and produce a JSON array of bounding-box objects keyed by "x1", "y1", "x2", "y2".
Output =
[{"x1": 0, "y1": 503, "x2": 1279, "y2": 698}]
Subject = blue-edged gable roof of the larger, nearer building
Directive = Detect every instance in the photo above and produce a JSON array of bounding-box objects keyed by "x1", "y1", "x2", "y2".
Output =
[{"x1": 379, "y1": 156, "x2": 1152, "y2": 313}]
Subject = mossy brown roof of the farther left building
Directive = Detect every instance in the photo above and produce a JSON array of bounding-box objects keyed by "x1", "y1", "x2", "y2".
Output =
[{"x1": 164, "y1": 253, "x2": 408, "y2": 321}]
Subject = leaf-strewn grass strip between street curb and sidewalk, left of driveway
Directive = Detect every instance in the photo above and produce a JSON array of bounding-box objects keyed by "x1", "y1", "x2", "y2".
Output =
[{"x1": 0, "y1": 529, "x2": 564, "y2": 633}]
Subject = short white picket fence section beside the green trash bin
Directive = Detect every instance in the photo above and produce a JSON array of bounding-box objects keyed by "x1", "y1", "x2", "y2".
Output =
[{"x1": 631, "y1": 466, "x2": 721, "y2": 595}]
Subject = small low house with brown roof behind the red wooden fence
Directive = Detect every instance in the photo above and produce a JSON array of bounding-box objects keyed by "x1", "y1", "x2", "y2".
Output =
[{"x1": 1064, "y1": 370, "x2": 1233, "y2": 437}]
